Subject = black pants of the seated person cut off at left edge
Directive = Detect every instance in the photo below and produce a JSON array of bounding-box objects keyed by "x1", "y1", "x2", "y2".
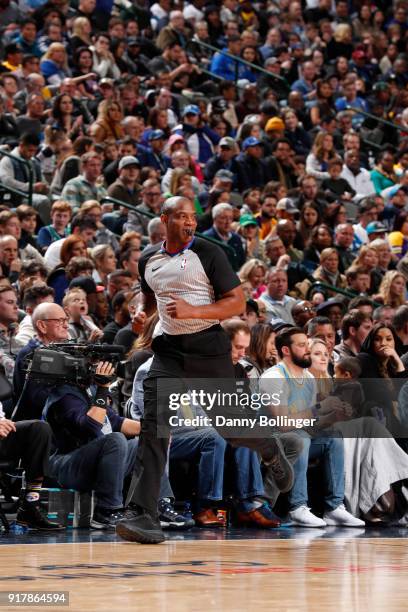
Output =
[{"x1": 0, "y1": 421, "x2": 52, "y2": 482}]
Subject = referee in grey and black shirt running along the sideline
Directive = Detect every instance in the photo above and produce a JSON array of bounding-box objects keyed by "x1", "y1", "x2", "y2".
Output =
[{"x1": 116, "y1": 197, "x2": 293, "y2": 544}]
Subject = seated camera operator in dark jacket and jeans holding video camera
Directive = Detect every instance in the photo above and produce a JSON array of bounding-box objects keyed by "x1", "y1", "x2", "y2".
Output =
[{"x1": 42, "y1": 360, "x2": 140, "y2": 529}]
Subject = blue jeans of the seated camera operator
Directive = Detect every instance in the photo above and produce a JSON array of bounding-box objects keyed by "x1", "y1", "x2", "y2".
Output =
[{"x1": 50, "y1": 432, "x2": 173, "y2": 509}]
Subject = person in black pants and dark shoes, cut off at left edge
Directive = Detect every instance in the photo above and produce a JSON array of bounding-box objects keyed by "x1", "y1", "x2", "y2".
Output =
[{"x1": 0, "y1": 412, "x2": 63, "y2": 530}]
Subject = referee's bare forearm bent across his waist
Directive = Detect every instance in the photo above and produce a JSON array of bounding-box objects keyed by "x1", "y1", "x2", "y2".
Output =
[{"x1": 166, "y1": 286, "x2": 245, "y2": 321}]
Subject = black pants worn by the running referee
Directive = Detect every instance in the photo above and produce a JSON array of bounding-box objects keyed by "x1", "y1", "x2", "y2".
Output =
[{"x1": 131, "y1": 325, "x2": 286, "y2": 516}]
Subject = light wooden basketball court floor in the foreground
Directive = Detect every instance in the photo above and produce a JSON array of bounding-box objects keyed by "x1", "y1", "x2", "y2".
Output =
[{"x1": 0, "y1": 527, "x2": 408, "y2": 612}]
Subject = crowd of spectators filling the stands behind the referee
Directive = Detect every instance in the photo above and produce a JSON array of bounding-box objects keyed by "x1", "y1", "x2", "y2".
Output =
[{"x1": 0, "y1": 0, "x2": 408, "y2": 527}]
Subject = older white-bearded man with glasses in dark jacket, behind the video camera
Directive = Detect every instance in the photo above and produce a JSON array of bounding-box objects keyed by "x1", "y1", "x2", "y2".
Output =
[{"x1": 13, "y1": 302, "x2": 68, "y2": 421}]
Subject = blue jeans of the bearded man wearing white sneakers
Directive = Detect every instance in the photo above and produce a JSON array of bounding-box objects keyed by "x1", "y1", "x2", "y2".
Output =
[{"x1": 289, "y1": 436, "x2": 344, "y2": 510}]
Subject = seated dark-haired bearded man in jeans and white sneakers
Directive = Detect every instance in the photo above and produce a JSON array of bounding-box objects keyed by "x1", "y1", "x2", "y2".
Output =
[{"x1": 261, "y1": 327, "x2": 365, "y2": 527}]
